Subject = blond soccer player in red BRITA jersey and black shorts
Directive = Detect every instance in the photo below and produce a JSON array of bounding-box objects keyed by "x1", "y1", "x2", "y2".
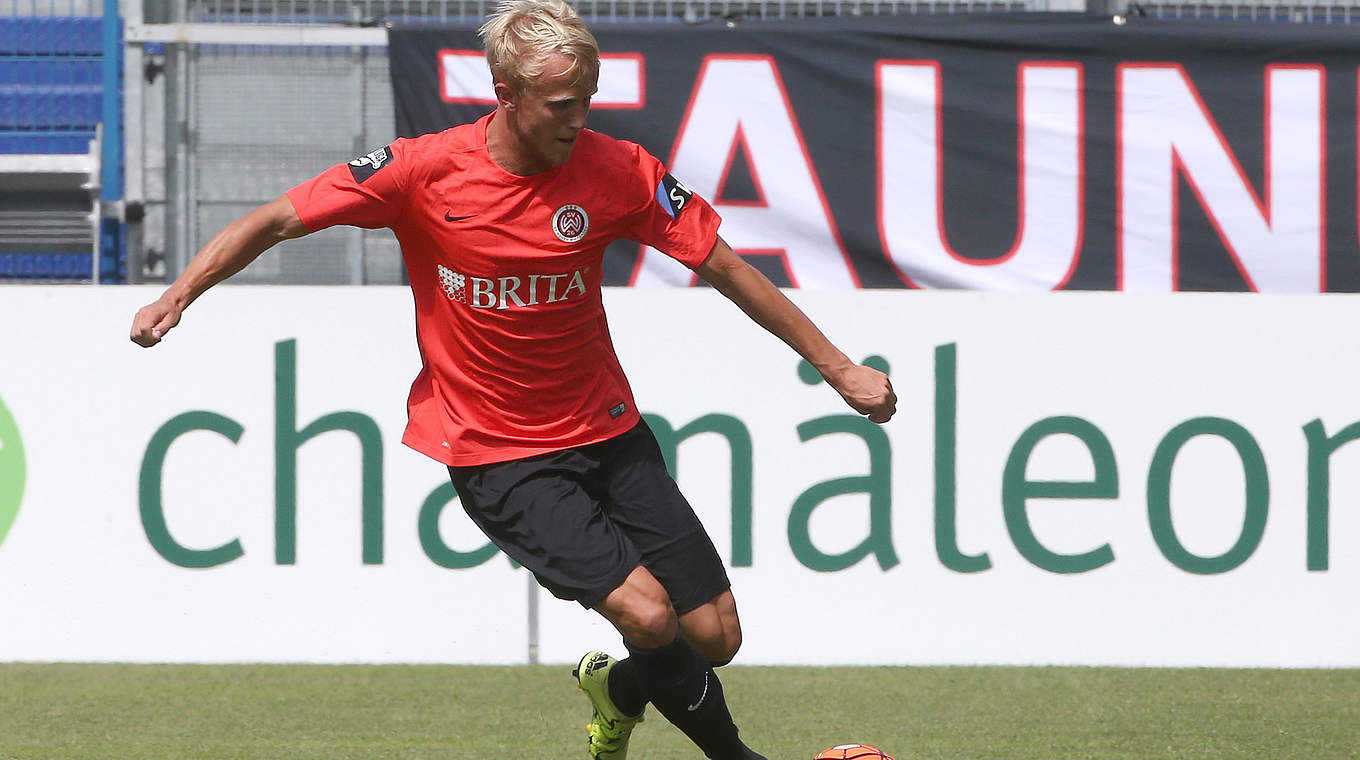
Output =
[{"x1": 132, "y1": 0, "x2": 896, "y2": 760}]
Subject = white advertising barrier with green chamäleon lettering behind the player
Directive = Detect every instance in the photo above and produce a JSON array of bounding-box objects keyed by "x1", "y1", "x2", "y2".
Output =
[{"x1": 0, "y1": 287, "x2": 1360, "y2": 666}]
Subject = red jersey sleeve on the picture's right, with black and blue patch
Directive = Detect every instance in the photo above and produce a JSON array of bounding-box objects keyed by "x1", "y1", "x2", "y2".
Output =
[{"x1": 628, "y1": 145, "x2": 722, "y2": 269}]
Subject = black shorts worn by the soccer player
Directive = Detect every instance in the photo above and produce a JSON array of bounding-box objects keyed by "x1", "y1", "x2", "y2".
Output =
[{"x1": 449, "y1": 421, "x2": 732, "y2": 615}]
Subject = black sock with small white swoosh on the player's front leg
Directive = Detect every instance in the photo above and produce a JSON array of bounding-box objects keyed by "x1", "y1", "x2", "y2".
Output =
[{"x1": 622, "y1": 636, "x2": 764, "y2": 760}]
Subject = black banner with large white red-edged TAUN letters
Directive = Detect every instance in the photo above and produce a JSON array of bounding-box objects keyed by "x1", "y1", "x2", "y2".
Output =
[{"x1": 389, "y1": 14, "x2": 1360, "y2": 292}]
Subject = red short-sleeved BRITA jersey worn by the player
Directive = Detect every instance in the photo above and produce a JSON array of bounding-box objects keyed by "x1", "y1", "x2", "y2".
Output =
[{"x1": 288, "y1": 116, "x2": 721, "y2": 466}]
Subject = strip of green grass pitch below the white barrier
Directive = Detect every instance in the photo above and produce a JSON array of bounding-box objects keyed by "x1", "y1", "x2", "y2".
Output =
[{"x1": 0, "y1": 665, "x2": 1360, "y2": 760}]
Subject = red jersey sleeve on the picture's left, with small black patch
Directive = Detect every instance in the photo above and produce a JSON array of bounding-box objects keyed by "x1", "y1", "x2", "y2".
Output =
[{"x1": 287, "y1": 140, "x2": 409, "y2": 232}]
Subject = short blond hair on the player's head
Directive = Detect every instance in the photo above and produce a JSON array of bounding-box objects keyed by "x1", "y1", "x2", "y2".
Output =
[{"x1": 477, "y1": 0, "x2": 600, "y2": 90}]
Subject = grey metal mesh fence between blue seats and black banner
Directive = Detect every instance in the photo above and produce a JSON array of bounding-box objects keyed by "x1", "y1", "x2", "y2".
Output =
[{"x1": 153, "y1": 45, "x2": 403, "y2": 284}]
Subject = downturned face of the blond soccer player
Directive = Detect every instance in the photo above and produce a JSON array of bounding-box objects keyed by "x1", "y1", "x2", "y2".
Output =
[{"x1": 513, "y1": 53, "x2": 596, "y2": 171}]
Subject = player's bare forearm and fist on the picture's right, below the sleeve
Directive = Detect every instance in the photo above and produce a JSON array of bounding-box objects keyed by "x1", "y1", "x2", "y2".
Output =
[{"x1": 695, "y1": 238, "x2": 898, "y2": 423}]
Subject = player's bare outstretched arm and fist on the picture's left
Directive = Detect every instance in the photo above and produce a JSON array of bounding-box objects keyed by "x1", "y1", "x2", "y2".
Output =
[{"x1": 132, "y1": 196, "x2": 310, "y2": 348}]
